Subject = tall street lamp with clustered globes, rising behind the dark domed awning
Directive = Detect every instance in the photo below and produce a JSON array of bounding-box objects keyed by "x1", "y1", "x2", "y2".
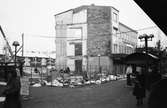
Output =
[{"x1": 139, "y1": 34, "x2": 154, "y2": 90}]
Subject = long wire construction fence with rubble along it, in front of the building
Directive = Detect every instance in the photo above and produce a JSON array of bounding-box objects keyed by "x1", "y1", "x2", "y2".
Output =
[{"x1": 23, "y1": 65, "x2": 126, "y2": 86}]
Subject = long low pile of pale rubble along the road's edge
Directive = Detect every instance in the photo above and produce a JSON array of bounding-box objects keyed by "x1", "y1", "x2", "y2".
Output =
[{"x1": 32, "y1": 75, "x2": 123, "y2": 88}]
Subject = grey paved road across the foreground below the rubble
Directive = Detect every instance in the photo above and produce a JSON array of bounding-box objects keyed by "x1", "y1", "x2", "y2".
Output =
[{"x1": 23, "y1": 80, "x2": 149, "y2": 108}]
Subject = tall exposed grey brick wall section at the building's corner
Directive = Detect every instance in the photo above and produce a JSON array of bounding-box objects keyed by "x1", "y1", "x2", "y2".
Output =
[{"x1": 87, "y1": 6, "x2": 111, "y2": 56}]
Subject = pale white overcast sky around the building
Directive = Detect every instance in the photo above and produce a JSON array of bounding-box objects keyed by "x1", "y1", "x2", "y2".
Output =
[{"x1": 0, "y1": 0, "x2": 166, "y2": 57}]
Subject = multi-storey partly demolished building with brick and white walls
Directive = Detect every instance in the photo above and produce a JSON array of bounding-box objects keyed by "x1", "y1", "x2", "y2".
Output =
[{"x1": 55, "y1": 5, "x2": 137, "y2": 73}]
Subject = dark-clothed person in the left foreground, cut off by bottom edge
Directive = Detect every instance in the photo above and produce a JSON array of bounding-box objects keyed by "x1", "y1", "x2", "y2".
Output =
[{"x1": 2, "y1": 69, "x2": 21, "y2": 108}]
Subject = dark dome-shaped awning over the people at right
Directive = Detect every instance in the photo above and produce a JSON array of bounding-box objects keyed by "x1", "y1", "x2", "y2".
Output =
[{"x1": 124, "y1": 53, "x2": 159, "y2": 65}]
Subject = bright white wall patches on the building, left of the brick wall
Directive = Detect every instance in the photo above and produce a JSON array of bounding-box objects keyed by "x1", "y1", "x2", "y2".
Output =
[{"x1": 67, "y1": 10, "x2": 87, "y2": 70}]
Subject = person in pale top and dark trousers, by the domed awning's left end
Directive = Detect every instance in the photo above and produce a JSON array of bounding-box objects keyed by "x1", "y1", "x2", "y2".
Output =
[{"x1": 126, "y1": 65, "x2": 132, "y2": 86}]
